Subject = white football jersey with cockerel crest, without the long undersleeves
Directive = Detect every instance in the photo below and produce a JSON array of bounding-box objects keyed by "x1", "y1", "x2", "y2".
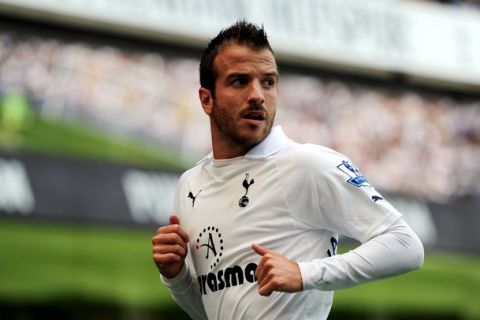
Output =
[{"x1": 166, "y1": 127, "x2": 400, "y2": 320}]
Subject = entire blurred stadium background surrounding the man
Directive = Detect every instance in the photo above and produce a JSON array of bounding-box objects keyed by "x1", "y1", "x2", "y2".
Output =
[{"x1": 0, "y1": 0, "x2": 480, "y2": 319}]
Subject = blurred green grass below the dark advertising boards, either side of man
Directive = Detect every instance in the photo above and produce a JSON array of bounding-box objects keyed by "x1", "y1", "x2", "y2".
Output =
[{"x1": 0, "y1": 219, "x2": 480, "y2": 319}]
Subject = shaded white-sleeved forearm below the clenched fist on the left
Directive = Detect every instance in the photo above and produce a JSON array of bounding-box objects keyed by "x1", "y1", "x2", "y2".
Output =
[{"x1": 160, "y1": 264, "x2": 208, "y2": 320}]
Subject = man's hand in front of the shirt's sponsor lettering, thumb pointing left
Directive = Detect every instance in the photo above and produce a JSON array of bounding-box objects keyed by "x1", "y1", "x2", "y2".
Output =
[{"x1": 252, "y1": 243, "x2": 303, "y2": 296}]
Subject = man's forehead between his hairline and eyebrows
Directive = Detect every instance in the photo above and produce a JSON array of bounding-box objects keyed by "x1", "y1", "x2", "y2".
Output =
[{"x1": 214, "y1": 45, "x2": 277, "y2": 77}]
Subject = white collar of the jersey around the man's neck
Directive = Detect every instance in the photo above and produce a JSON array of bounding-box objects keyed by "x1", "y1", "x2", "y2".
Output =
[{"x1": 197, "y1": 126, "x2": 291, "y2": 164}]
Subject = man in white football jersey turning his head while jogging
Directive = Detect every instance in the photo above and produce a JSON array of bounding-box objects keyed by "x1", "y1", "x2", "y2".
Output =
[{"x1": 152, "y1": 21, "x2": 423, "y2": 320}]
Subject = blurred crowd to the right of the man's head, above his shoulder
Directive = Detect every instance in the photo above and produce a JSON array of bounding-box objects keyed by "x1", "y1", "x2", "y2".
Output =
[{"x1": 279, "y1": 76, "x2": 480, "y2": 202}]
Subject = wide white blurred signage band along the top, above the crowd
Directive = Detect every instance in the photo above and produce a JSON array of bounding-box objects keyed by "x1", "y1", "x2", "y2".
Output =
[{"x1": 0, "y1": 0, "x2": 480, "y2": 87}]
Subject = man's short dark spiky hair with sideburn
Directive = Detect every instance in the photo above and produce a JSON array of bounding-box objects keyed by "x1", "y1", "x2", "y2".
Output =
[{"x1": 200, "y1": 20, "x2": 273, "y2": 95}]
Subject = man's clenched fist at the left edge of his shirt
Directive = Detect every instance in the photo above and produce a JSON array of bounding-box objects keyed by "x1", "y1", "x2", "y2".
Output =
[{"x1": 152, "y1": 215, "x2": 189, "y2": 278}]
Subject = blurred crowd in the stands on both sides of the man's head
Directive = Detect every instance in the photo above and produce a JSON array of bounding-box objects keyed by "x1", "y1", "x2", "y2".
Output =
[{"x1": 0, "y1": 33, "x2": 480, "y2": 202}]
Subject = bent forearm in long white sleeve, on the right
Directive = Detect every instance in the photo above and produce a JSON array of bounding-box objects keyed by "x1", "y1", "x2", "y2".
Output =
[{"x1": 299, "y1": 220, "x2": 424, "y2": 291}]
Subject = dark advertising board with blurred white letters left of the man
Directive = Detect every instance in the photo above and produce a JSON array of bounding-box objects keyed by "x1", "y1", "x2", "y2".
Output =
[{"x1": 0, "y1": 153, "x2": 179, "y2": 226}]
